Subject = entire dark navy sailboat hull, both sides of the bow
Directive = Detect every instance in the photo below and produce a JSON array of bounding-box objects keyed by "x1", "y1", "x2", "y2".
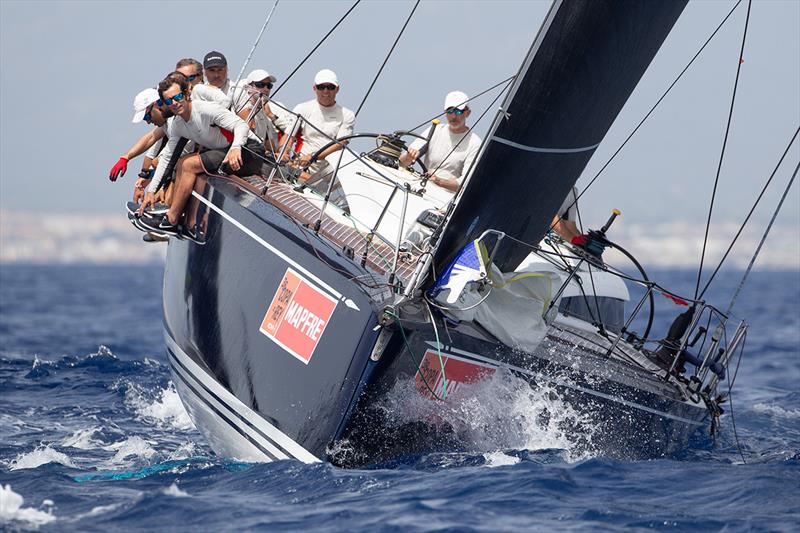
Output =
[{"x1": 164, "y1": 177, "x2": 708, "y2": 466}]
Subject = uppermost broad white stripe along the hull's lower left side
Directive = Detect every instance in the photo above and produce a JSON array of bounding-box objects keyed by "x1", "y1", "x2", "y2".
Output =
[{"x1": 164, "y1": 331, "x2": 320, "y2": 463}]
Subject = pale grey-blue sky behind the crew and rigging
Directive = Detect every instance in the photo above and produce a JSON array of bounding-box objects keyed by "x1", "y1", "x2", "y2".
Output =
[{"x1": 0, "y1": 0, "x2": 800, "y2": 237}]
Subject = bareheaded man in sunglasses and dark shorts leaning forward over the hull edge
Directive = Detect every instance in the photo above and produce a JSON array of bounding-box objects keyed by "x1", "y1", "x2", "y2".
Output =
[{"x1": 139, "y1": 75, "x2": 264, "y2": 235}]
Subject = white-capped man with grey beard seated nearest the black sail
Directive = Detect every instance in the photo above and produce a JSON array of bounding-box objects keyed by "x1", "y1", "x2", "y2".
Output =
[{"x1": 400, "y1": 91, "x2": 481, "y2": 192}]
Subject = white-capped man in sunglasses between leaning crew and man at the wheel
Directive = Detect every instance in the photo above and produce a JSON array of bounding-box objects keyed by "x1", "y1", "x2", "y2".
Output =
[{"x1": 234, "y1": 69, "x2": 294, "y2": 154}]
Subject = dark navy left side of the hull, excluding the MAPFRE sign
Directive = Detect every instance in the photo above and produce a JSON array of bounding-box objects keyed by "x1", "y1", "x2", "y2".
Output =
[{"x1": 164, "y1": 178, "x2": 377, "y2": 459}]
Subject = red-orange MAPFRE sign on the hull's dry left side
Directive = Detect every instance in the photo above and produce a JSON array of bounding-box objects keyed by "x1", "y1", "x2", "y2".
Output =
[{"x1": 259, "y1": 268, "x2": 337, "y2": 364}]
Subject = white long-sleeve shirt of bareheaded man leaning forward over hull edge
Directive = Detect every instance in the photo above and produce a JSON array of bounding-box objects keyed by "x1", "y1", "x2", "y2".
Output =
[{"x1": 147, "y1": 101, "x2": 257, "y2": 193}]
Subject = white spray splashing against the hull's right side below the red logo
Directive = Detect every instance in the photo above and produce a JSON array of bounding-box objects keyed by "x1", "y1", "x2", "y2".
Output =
[{"x1": 381, "y1": 370, "x2": 595, "y2": 461}]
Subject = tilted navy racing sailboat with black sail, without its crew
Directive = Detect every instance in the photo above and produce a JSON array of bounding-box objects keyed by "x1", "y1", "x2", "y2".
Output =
[{"x1": 147, "y1": 0, "x2": 792, "y2": 466}]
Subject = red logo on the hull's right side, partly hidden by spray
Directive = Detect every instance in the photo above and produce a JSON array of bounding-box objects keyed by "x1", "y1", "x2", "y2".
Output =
[{"x1": 414, "y1": 350, "x2": 497, "y2": 399}]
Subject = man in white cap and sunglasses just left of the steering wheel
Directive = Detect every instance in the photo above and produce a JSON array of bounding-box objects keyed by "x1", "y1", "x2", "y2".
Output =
[{"x1": 290, "y1": 69, "x2": 356, "y2": 179}]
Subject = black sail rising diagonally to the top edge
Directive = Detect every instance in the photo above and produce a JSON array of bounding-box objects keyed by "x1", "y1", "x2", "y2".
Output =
[{"x1": 435, "y1": 0, "x2": 686, "y2": 272}]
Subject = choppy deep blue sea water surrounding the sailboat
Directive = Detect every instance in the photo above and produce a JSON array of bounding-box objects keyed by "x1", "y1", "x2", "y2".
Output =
[{"x1": 0, "y1": 266, "x2": 800, "y2": 532}]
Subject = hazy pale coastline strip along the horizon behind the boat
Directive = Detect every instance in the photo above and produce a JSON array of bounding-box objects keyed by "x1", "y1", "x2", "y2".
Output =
[{"x1": 0, "y1": 211, "x2": 800, "y2": 270}]
